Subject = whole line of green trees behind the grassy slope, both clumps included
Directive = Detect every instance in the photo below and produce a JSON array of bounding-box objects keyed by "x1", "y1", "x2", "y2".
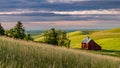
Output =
[{"x1": 0, "y1": 21, "x2": 70, "y2": 48}]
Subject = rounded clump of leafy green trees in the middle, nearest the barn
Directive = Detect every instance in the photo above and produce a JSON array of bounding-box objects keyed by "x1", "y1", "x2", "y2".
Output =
[{"x1": 44, "y1": 28, "x2": 70, "y2": 48}]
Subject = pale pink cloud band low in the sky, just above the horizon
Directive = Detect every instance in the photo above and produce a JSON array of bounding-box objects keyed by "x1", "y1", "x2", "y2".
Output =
[{"x1": 2, "y1": 20, "x2": 120, "y2": 30}]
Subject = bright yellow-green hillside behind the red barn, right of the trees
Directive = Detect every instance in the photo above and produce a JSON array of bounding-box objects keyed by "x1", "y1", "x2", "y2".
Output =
[{"x1": 70, "y1": 28, "x2": 120, "y2": 50}]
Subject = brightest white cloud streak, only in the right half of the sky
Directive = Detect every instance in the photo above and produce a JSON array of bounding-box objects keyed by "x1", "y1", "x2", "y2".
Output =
[{"x1": 53, "y1": 9, "x2": 120, "y2": 15}]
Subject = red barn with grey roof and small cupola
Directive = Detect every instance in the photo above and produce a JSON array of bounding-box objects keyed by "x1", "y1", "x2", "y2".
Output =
[{"x1": 82, "y1": 37, "x2": 101, "y2": 50}]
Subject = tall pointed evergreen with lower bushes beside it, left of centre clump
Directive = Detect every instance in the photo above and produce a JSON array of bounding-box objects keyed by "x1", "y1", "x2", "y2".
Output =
[{"x1": 5, "y1": 21, "x2": 32, "y2": 40}]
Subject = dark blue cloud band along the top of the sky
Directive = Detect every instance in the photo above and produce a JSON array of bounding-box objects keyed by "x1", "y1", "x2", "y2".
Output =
[{"x1": 0, "y1": 0, "x2": 120, "y2": 11}]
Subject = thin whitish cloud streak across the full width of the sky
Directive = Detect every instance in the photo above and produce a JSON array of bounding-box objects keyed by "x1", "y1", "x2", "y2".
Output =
[{"x1": 0, "y1": 9, "x2": 120, "y2": 15}]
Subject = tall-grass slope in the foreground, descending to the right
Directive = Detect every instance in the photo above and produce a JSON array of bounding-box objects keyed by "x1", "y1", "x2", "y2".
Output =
[{"x1": 0, "y1": 37, "x2": 120, "y2": 68}]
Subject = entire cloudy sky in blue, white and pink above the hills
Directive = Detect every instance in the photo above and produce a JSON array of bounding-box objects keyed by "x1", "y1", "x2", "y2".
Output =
[{"x1": 0, "y1": 0, "x2": 120, "y2": 30}]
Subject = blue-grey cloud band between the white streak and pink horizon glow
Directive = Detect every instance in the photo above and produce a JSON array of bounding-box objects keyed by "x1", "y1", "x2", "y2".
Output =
[{"x1": 0, "y1": 14, "x2": 120, "y2": 23}]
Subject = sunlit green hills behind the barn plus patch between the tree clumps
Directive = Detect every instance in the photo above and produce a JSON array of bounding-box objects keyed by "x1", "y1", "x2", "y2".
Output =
[{"x1": 34, "y1": 28, "x2": 120, "y2": 50}]
